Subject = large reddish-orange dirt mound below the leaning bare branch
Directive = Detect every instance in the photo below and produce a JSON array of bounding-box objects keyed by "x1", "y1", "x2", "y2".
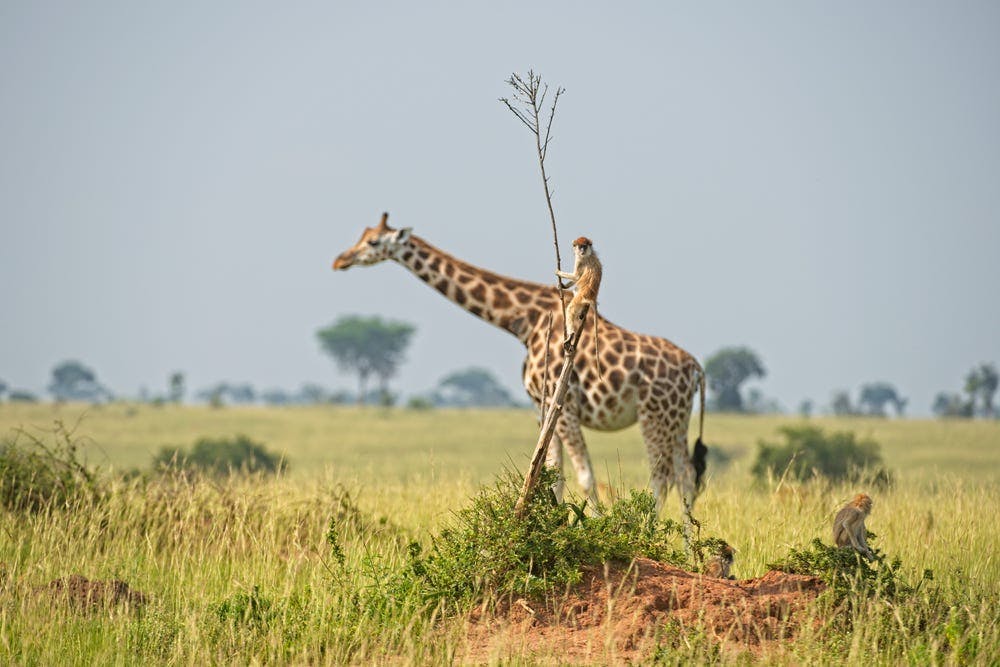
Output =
[{"x1": 466, "y1": 558, "x2": 825, "y2": 663}]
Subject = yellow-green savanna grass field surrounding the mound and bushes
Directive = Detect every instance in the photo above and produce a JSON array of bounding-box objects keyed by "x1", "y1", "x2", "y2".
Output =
[{"x1": 0, "y1": 404, "x2": 1000, "y2": 665}]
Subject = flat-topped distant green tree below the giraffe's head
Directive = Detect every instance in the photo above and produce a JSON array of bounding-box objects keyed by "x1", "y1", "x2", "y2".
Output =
[{"x1": 316, "y1": 315, "x2": 416, "y2": 402}]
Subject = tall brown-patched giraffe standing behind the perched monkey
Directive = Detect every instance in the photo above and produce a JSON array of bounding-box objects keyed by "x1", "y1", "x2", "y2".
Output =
[{"x1": 333, "y1": 213, "x2": 707, "y2": 521}]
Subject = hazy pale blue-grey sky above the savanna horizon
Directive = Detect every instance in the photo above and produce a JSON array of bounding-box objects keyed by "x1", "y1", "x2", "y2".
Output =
[{"x1": 0, "y1": 0, "x2": 1000, "y2": 414}]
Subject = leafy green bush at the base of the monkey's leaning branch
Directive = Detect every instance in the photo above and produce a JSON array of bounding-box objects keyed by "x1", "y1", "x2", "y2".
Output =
[{"x1": 390, "y1": 469, "x2": 686, "y2": 604}]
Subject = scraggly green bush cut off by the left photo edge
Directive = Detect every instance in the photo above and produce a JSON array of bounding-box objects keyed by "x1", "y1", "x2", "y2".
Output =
[{"x1": 0, "y1": 421, "x2": 104, "y2": 512}]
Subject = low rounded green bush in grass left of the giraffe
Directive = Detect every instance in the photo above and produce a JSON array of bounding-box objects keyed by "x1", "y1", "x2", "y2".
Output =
[{"x1": 154, "y1": 435, "x2": 288, "y2": 476}]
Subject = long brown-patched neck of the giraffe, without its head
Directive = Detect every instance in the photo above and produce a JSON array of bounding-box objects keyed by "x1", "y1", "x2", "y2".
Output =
[{"x1": 394, "y1": 236, "x2": 559, "y2": 344}]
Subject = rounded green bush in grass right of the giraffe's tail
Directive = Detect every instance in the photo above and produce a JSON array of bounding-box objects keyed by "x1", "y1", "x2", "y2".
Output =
[{"x1": 751, "y1": 426, "x2": 892, "y2": 487}]
